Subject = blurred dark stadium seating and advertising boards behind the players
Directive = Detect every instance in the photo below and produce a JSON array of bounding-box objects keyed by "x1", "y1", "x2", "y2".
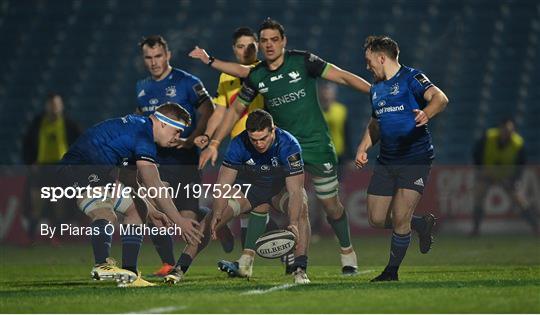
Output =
[{"x1": 0, "y1": 0, "x2": 540, "y2": 246}]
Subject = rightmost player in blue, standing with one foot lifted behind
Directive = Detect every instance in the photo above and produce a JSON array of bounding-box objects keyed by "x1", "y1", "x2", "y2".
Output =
[{"x1": 355, "y1": 36, "x2": 448, "y2": 282}]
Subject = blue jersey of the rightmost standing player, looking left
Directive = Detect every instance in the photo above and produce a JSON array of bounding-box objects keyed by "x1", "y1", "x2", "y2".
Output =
[{"x1": 370, "y1": 66, "x2": 434, "y2": 164}]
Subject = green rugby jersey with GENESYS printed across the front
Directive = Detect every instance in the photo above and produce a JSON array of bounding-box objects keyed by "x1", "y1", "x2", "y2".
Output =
[{"x1": 238, "y1": 50, "x2": 335, "y2": 155}]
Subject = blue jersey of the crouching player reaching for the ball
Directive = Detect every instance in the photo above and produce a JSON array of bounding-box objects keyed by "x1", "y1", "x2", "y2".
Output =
[{"x1": 223, "y1": 128, "x2": 304, "y2": 186}]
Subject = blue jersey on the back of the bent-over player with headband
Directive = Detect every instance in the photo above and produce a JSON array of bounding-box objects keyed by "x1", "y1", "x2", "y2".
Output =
[{"x1": 60, "y1": 115, "x2": 156, "y2": 166}]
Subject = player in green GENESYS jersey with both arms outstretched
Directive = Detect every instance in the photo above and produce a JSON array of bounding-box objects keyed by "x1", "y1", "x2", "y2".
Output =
[{"x1": 190, "y1": 18, "x2": 371, "y2": 275}]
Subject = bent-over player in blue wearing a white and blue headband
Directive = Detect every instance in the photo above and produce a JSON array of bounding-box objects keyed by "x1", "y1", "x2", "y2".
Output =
[{"x1": 59, "y1": 103, "x2": 202, "y2": 287}]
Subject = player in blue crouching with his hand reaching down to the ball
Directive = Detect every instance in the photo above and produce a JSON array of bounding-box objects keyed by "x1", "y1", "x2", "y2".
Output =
[{"x1": 207, "y1": 109, "x2": 311, "y2": 284}]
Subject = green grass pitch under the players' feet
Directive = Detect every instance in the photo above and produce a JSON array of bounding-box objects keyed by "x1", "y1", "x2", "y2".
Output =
[{"x1": 0, "y1": 236, "x2": 540, "y2": 313}]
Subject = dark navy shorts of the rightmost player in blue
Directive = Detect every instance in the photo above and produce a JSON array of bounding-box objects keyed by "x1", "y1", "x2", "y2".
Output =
[{"x1": 367, "y1": 160, "x2": 431, "y2": 196}]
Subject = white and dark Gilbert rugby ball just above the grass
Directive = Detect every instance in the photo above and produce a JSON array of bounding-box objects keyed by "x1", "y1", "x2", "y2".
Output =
[{"x1": 255, "y1": 230, "x2": 296, "y2": 259}]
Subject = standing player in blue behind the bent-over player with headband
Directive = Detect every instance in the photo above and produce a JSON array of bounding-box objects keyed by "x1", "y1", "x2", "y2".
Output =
[{"x1": 136, "y1": 35, "x2": 234, "y2": 277}]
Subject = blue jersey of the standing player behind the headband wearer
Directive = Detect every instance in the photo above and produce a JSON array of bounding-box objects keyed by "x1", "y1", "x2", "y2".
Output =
[{"x1": 136, "y1": 68, "x2": 210, "y2": 164}]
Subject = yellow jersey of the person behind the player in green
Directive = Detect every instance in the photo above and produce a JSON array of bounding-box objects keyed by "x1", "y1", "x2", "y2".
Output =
[{"x1": 213, "y1": 61, "x2": 264, "y2": 138}]
